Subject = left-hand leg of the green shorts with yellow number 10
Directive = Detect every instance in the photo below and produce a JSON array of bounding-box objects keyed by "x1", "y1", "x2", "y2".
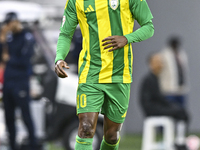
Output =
[{"x1": 76, "y1": 83, "x2": 104, "y2": 114}]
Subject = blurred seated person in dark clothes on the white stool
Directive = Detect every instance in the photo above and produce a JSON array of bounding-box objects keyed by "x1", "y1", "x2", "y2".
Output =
[{"x1": 140, "y1": 53, "x2": 188, "y2": 150}]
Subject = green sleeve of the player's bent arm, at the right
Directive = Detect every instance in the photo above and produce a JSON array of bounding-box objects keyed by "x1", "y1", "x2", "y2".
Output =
[{"x1": 125, "y1": 0, "x2": 154, "y2": 43}]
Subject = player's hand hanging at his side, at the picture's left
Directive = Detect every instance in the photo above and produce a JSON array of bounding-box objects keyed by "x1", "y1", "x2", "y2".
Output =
[{"x1": 55, "y1": 60, "x2": 69, "y2": 78}]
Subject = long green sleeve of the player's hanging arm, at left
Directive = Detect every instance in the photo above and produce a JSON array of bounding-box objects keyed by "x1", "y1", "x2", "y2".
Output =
[{"x1": 55, "y1": 0, "x2": 78, "y2": 63}]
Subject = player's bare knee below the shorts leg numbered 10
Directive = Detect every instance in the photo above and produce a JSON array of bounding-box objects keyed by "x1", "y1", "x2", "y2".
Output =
[{"x1": 79, "y1": 122, "x2": 95, "y2": 138}]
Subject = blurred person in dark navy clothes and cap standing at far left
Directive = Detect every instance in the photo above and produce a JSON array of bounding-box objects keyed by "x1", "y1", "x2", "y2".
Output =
[{"x1": 0, "y1": 12, "x2": 36, "y2": 150}]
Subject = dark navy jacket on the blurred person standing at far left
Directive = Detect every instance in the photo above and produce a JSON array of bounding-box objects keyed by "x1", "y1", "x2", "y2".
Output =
[{"x1": 0, "y1": 30, "x2": 35, "y2": 83}]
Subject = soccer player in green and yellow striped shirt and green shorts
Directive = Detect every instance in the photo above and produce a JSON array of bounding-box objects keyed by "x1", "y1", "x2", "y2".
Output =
[{"x1": 55, "y1": 0, "x2": 154, "y2": 150}]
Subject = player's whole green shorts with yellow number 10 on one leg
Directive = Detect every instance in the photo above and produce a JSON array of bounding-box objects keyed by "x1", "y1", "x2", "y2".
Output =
[{"x1": 77, "y1": 83, "x2": 131, "y2": 123}]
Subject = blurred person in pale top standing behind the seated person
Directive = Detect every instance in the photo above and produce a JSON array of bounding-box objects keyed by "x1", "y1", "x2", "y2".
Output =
[{"x1": 159, "y1": 36, "x2": 189, "y2": 107}]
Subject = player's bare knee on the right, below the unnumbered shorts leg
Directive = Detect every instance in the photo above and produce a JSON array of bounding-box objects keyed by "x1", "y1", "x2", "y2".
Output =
[{"x1": 104, "y1": 131, "x2": 119, "y2": 144}]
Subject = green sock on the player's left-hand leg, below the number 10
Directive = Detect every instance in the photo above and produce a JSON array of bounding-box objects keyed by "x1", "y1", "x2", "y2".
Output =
[{"x1": 75, "y1": 135, "x2": 93, "y2": 150}]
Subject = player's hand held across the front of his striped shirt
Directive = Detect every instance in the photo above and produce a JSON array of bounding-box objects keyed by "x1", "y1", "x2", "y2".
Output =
[{"x1": 102, "y1": 35, "x2": 128, "y2": 52}]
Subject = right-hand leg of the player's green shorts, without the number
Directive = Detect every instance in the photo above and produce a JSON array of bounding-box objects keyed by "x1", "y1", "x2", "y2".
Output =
[{"x1": 102, "y1": 83, "x2": 131, "y2": 123}]
